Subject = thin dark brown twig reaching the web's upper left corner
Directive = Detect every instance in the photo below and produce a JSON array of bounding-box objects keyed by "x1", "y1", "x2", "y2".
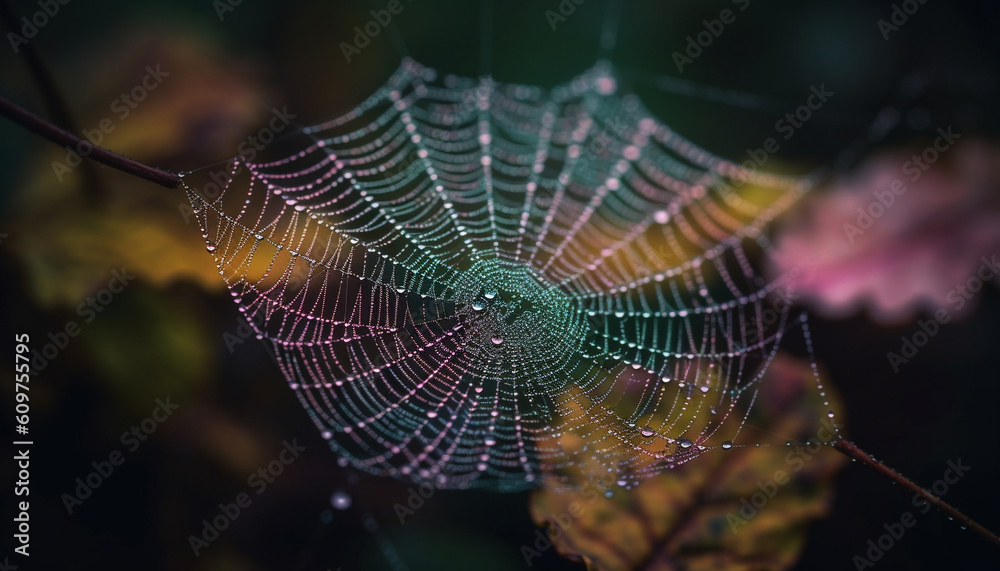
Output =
[{"x1": 0, "y1": 97, "x2": 181, "y2": 188}]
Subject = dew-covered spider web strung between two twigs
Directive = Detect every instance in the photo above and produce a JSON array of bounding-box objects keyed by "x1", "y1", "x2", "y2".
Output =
[{"x1": 183, "y1": 59, "x2": 836, "y2": 490}]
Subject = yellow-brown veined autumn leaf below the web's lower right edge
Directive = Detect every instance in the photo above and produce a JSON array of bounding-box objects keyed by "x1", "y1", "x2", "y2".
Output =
[{"x1": 522, "y1": 356, "x2": 846, "y2": 571}]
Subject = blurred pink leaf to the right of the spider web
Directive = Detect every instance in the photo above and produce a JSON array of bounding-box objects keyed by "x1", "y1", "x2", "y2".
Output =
[{"x1": 769, "y1": 138, "x2": 1000, "y2": 324}]
